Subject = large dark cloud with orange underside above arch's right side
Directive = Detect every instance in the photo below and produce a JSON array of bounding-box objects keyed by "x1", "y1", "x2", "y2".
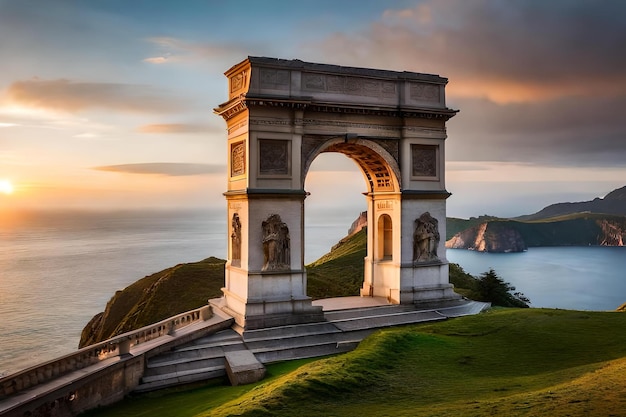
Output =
[{"x1": 309, "y1": 0, "x2": 626, "y2": 102}]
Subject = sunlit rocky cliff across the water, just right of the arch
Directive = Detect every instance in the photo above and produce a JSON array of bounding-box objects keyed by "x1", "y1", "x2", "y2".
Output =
[{"x1": 446, "y1": 222, "x2": 528, "y2": 253}]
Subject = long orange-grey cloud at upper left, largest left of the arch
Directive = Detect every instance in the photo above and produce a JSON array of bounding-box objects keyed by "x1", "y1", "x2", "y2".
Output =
[{"x1": 7, "y1": 79, "x2": 182, "y2": 113}]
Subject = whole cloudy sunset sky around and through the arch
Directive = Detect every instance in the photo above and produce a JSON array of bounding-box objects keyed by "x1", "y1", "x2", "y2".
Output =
[{"x1": 0, "y1": 0, "x2": 626, "y2": 217}]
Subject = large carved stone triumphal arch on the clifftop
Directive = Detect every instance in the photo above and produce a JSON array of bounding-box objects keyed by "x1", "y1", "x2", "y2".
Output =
[{"x1": 215, "y1": 57, "x2": 458, "y2": 330}]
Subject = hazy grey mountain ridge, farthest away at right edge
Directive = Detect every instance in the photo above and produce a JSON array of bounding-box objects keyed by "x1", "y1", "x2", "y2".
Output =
[{"x1": 514, "y1": 186, "x2": 626, "y2": 221}]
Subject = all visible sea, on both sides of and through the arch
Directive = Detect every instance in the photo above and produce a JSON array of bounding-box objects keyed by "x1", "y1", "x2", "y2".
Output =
[{"x1": 0, "y1": 210, "x2": 626, "y2": 375}]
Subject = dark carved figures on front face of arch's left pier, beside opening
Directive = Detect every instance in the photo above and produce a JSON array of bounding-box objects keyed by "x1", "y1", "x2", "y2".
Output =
[{"x1": 261, "y1": 214, "x2": 291, "y2": 271}]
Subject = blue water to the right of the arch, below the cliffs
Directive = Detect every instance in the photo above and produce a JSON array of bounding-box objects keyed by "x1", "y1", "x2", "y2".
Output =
[{"x1": 446, "y1": 246, "x2": 626, "y2": 310}]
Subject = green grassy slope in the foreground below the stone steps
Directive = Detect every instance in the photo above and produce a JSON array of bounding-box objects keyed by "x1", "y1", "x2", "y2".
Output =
[{"x1": 80, "y1": 309, "x2": 626, "y2": 417}]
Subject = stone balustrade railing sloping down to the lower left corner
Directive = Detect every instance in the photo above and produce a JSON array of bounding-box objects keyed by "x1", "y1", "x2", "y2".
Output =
[{"x1": 0, "y1": 306, "x2": 211, "y2": 400}]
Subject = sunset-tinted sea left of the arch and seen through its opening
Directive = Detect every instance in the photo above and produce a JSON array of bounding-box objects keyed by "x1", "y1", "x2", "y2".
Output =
[{"x1": 0, "y1": 210, "x2": 358, "y2": 375}]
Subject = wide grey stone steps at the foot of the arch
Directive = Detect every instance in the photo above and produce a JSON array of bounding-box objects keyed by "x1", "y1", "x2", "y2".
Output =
[{"x1": 135, "y1": 302, "x2": 487, "y2": 392}]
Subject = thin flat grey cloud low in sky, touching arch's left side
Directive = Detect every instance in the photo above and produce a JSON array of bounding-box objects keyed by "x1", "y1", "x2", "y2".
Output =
[{"x1": 93, "y1": 162, "x2": 226, "y2": 177}]
